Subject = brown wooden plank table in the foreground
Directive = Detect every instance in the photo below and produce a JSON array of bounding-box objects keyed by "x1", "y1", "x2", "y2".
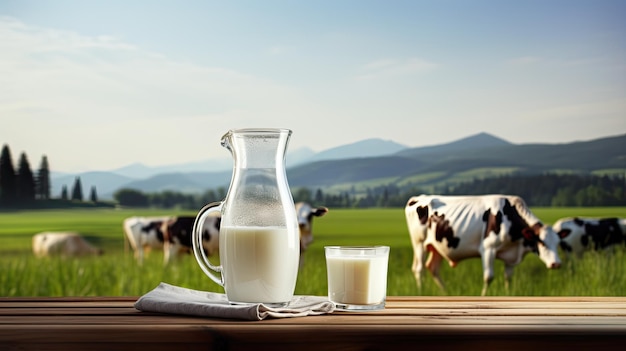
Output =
[{"x1": 0, "y1": 296, "x2": 626, "y2": 351}]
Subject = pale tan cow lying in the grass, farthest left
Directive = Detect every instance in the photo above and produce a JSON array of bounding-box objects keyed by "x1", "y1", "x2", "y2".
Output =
[{"x1": 33, "y1": 232, "x2": 103, "y2": 257}]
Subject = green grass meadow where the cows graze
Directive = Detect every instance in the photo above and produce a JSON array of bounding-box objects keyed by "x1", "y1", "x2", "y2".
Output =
[{"x1": 0, "y1": 207, "x2": 626, "y2": 296}]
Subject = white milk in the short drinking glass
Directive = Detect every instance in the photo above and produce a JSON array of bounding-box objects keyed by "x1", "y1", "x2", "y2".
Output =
[{"x1": 326, "y1": 256, "x2": 388, "y2": 305}]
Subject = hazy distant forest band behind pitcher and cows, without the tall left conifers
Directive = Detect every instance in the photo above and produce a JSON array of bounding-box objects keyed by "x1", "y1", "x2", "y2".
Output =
[{"x1": 114, "y1": 174, "x2": 626, "y2": 210}]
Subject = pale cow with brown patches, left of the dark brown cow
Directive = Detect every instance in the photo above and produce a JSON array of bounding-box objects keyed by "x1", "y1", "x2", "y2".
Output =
[{"x1": 124, "y1": 217, "x2": 171, "y2": 264}]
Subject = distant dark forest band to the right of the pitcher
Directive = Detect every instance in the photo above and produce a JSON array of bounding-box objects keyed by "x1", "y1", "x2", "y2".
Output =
[{"x1": 294, "y1": 173, "x2": 626, "y2": 208}]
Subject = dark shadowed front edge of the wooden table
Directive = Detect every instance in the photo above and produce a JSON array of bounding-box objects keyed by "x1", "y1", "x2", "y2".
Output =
[{"x1": 0, "y1": 323, "x2": 625, "y2": 351}]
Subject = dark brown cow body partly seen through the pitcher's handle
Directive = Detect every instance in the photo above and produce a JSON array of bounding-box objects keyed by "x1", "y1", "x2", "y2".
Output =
[{"x1": 161, "y1": 215, "x2": 222, "y2": 264}]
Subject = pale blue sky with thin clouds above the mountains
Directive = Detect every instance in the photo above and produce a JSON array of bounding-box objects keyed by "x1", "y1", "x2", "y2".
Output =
[{"x1": 0, "y1": 0, "x2": 626, "y2": 172}]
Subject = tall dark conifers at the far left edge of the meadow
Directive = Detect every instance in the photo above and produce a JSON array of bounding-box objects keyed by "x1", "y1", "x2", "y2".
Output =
[{"x1": 0, "y1": 144, "x2": 99, "y2": 208}]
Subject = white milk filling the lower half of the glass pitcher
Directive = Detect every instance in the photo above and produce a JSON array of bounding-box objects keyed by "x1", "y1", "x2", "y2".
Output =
[{"x1": 220, "y1": 226, "x2": 300, "y2": 303}]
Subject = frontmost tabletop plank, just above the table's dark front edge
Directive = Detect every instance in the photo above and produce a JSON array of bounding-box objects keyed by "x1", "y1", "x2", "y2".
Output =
[{"x1": 0, "y1": 317, "x2": 626, "y2": 334}]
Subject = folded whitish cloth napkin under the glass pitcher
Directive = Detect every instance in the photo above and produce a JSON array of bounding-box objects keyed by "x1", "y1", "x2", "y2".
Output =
[{"x1": 135, "y1": 283, "x2": 335, "y2": 321}]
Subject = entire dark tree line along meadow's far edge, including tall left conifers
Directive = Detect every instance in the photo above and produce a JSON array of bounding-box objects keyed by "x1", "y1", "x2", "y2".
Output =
[{"x1": 0, "y1": 145, "x2": 626, "y2": 210}]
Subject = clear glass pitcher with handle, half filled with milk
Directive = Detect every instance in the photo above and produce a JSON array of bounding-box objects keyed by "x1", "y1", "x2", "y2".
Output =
[{"x1": 192, "y1": 129, "x2": 300, "y2": 306}]
